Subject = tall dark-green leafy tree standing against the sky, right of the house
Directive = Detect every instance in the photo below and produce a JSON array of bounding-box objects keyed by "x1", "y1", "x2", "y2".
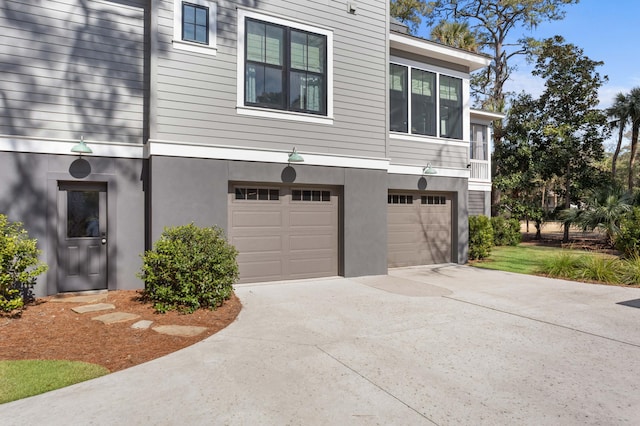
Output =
[{"x1": 533, "y1": 36, "x2": 609, "y2": 242}]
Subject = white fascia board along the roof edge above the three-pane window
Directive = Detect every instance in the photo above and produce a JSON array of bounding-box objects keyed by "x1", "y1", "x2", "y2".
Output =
[{"x1": 389, "y1": 33, "x2": 491, "y2": 72}]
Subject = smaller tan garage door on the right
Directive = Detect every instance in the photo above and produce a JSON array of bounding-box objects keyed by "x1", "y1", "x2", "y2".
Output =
[{"x1": 387, "y1": 192, "x2": 451, "y2": 267}]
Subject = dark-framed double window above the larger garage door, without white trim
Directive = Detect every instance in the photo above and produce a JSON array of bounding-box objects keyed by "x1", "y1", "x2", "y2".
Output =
[{"x1": 244, "y1": 18, "x2": 327, "y2": 115}]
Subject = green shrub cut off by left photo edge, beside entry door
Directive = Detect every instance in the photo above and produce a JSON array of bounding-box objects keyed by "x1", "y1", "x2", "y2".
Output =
[{"x1": 0, "y1": 214, "x2": 47, "y2": 314}]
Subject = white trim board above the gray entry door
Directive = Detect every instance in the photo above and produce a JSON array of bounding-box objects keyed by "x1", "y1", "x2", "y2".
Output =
[{"x1": 0, "y1": 136, "x2": 144, "y2": 158}]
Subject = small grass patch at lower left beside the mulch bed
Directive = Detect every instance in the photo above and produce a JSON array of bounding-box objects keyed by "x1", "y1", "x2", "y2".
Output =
[{"x1": 0, "y1": 360, "x2": 109, "y2": 404}]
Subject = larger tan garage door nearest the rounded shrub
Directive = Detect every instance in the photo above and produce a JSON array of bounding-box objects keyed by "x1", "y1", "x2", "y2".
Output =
[{"x1": 228, "y1": 185, "x2": 338, "y2": 283}]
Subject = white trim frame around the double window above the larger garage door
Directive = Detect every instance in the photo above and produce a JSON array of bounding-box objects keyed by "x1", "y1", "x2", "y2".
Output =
[{"x1": 236, "y1": 9, "x2": 333, "y2": 125}]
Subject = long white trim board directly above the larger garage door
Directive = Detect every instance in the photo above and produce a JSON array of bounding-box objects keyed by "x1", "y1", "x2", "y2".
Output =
[{"x1": 147, "y1": 139, "x2": 389, "y2": 170}]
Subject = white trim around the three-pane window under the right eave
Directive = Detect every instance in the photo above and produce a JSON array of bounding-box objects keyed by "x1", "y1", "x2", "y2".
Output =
[{"x1": 389, "y1": 56, "x2": 471, "y2": 141}]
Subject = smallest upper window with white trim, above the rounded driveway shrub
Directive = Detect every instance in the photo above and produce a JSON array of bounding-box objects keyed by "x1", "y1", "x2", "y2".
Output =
[{"x1": 173, "y1": 0, "x2": 216, "y2": 55}]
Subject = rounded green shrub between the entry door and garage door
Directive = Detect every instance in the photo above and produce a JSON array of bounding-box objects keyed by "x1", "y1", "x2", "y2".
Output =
[{"x1": 139, "y1": 224, "x2": 238, "y2": 313}]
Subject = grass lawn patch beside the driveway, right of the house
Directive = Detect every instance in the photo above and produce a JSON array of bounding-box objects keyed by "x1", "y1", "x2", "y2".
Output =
[{"x1": 471, "y1": 245, "x2": 592, "y2": 275}]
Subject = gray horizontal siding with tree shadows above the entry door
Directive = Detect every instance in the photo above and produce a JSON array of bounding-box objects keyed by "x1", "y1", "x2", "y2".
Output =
[{"x1": 0, "y1": 0, "x2": 147, "y2": 143}]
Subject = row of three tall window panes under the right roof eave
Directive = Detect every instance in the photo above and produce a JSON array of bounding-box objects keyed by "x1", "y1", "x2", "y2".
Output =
[{"x1": 389, "y1": 64, "x2": 462, "y2": 139}]
